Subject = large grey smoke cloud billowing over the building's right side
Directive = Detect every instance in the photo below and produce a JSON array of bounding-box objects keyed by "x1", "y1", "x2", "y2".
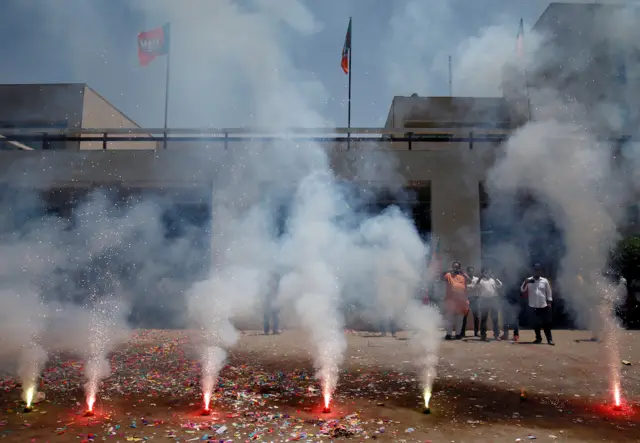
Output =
[{"x1": 382, "y1": 2, "x2": 638, "y2": 334}]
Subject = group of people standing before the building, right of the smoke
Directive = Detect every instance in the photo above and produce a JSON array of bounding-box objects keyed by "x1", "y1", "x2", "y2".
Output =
[{"x1": 443, "y1": 262, "x2": 554, "y2": 345}]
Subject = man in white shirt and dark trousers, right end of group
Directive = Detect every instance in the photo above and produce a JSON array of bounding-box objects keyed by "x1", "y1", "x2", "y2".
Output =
[{"x1": 520, "y1": 263, "x2": 555, "y2": 346}]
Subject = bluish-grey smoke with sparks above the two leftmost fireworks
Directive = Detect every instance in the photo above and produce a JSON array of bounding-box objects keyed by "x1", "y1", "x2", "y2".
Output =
[{"x1": 0, "y1": 187, "x2": 202, "y2": 406}]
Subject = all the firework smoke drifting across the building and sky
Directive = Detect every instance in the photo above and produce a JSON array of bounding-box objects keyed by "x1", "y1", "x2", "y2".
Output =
[{"x1": 0, "y1": 0, "x2": 639, "y2": 416}]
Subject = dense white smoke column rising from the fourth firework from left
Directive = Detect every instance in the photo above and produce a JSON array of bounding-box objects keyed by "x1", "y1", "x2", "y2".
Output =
[{"x1": 278, "y1": 172, "x2": 349, "y2": 407}]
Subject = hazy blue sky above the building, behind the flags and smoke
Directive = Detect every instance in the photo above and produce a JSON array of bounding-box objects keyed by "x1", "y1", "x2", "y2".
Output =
[{"x1": 0, "y1": 0, "x2": 549, "y2": 128}]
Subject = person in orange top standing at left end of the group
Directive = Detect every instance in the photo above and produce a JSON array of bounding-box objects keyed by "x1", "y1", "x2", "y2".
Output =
[{"x1": 444, "y1": 262, "x2": 471, "y2": 340}]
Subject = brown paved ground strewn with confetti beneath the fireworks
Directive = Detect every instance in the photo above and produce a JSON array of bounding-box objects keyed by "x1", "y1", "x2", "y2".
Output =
[{"x1": 0, "y1": 331, "x2": 640, "y2": 443}]
